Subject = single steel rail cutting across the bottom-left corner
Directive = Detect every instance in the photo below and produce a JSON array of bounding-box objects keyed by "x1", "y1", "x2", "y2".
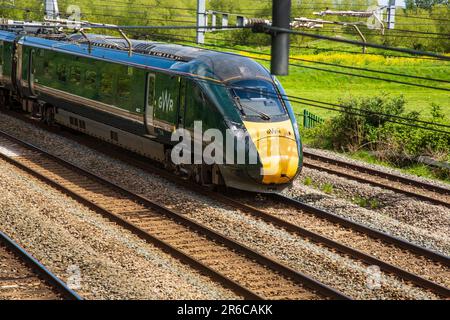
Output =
[{"x1": 0, "y1": 231, "x2": 83, "y2": 300}]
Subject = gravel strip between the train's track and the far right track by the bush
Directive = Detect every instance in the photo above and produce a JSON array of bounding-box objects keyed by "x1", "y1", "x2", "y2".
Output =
[{"x1": 285, "y1": 168, "x2": 450, "y2": 256}]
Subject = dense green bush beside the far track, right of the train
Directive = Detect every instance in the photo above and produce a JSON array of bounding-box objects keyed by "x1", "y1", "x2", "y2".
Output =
[{"x1": 306, "y1": 95, "x2": 450, "y2": 165}]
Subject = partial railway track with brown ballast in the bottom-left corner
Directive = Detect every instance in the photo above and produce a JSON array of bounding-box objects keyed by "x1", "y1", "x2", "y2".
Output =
[{"x1": 0, "y1": 232, "x2": 81, "y2": 300}]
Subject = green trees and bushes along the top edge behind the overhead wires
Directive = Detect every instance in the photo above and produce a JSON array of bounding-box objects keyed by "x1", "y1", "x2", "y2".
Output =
[{"x1": 0, "y1": 0, "x2": 450, "y2": 52}]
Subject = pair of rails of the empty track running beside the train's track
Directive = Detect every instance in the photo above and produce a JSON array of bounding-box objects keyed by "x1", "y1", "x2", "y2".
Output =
[{"x1": 0, "y1": 131, "x2": 351, "y2": 300}]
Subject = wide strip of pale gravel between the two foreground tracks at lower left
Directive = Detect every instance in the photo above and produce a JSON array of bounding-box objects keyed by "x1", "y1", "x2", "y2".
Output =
[{"x1": 0, "y1": 160, "x2": 239, "y2": 299}]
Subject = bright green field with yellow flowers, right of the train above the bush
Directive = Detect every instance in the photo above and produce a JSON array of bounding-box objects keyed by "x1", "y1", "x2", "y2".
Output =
[{"x1": 236, "y1": 49, "x2": 450, "y2": 123}]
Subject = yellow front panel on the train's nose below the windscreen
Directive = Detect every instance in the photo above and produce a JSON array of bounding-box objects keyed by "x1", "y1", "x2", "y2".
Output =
[{"x1": 244, "y1": 120, "x2": 299, "y2": 184}]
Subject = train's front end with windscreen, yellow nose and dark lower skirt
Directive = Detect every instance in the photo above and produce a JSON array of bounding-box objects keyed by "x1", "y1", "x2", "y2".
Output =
[{"x1": 217, "y1": 79, "x2": 302, "y2": 192}]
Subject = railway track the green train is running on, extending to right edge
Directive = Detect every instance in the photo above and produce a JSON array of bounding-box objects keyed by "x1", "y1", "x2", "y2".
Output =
[{"x1": 2, "y1": 111, "x2": 450, "y2": 298}]
